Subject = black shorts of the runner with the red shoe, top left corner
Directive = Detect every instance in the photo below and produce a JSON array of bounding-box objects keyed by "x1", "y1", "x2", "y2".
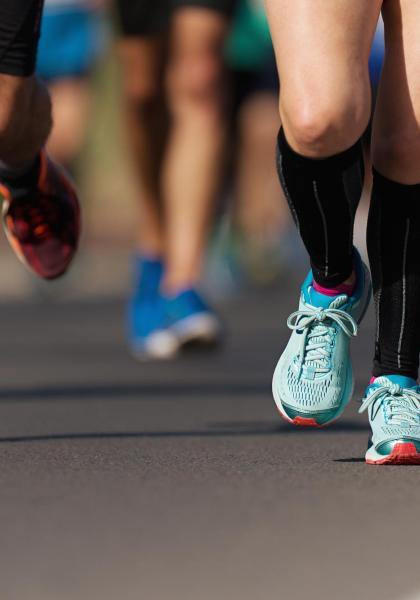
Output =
[{"x1": 0, "y1": 0, "x2": 44, "y2": 77}]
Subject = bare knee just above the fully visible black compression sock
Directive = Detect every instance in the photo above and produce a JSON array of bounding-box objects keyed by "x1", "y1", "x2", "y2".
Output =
[{"x1": 280, "y1": 98, "x2": 369, "y2": 157}]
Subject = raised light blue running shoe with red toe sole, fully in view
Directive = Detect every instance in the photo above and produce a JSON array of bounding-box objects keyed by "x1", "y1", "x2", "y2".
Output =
[{"x1": 273, "y1": 249, "x2": 371, "y2": 427}]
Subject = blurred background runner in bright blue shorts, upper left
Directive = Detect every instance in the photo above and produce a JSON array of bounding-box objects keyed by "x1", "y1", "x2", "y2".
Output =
[{"x1": 37, "y1": 0, "x2": 107, "y2": 171}]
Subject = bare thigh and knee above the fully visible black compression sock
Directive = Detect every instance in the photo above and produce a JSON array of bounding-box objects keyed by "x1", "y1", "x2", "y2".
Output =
[{"x1": 266, "y1": 0, "x2": 382, "y2": 157}]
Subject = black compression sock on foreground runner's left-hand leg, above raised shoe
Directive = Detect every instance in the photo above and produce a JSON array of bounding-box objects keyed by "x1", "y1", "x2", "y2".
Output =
[{"x1": 277, "y1": 129, "x2": 364, "y2": 288}]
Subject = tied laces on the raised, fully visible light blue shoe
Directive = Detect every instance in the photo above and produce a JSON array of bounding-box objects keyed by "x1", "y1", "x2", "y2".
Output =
[{"x1": 287, "y1": 307, "x2": 357, "y2": 379}]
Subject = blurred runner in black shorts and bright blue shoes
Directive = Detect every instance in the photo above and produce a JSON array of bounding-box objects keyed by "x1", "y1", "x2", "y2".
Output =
[{"x1": 118, "y1": 0, "x2": 234, "y2": 357}]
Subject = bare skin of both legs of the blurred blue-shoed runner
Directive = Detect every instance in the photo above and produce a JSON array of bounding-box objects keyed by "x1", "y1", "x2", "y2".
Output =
[{"x1": 121, "y1": 8, "x2": 228, "y2": 293}]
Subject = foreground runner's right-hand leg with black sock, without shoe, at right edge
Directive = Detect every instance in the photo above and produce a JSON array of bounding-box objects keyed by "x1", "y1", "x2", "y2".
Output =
[{"x1": 368, "y1": 0, "x2": 420, "y2": 379}]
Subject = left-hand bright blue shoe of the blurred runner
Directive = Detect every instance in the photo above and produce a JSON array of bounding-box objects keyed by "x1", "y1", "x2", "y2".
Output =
[{"x1": 128, "y1": 256, "x2": 178, "y2": 359}]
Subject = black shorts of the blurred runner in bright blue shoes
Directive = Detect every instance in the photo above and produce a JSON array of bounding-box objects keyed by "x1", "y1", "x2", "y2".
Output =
[{"x1": 116, "y1": 0, "x2": 236, "y2": 36}]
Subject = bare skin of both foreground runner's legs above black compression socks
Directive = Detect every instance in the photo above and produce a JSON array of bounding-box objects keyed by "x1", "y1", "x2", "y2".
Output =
[{"x1": 266, "y1": 0, "x2": 420, "y2": 284}]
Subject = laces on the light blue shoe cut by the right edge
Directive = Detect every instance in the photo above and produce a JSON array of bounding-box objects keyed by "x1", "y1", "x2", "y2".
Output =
[{"x1": 359, "y1": 383, "x2": 420, "y2": 425}]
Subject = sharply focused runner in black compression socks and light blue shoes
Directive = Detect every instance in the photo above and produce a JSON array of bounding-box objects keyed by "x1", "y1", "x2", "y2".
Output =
[{"x1": 267, "y1": 0, "x2": 420, "y2": 464}]
